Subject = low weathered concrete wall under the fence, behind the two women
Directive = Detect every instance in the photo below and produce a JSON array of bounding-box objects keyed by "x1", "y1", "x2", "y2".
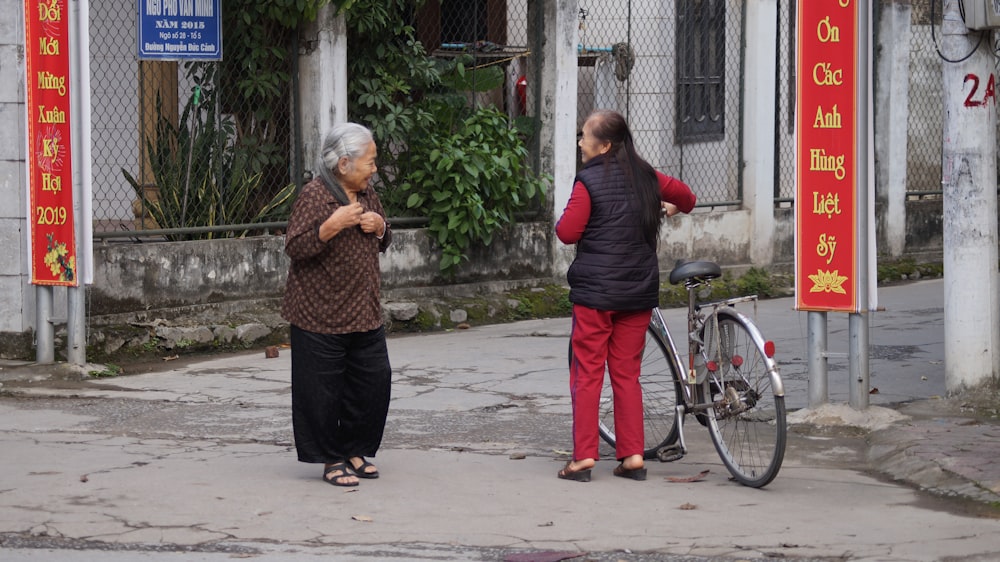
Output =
[{"x1": 88, "y1": 211, "x2": 764, "y2": 317}]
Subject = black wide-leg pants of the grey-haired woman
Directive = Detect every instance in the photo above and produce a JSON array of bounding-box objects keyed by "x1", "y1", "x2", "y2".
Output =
[{"x1": 291, "y1": 326, "x2": 392, "y2": 464}]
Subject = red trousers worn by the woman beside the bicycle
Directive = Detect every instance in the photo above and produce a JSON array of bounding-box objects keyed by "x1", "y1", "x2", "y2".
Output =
[{"x1": 569, "y1": 305, "x2": 652, "y2": 460}]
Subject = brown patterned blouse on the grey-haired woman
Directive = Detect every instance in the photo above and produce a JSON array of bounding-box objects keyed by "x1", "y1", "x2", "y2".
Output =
[{"x1": 281, "y1": 179, "x2": 392, "y2": 334}]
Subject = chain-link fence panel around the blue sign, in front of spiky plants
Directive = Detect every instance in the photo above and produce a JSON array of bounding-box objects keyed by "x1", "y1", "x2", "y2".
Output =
[{"x1": 90, "y1": 0, "x2": 297, "y2": 239}]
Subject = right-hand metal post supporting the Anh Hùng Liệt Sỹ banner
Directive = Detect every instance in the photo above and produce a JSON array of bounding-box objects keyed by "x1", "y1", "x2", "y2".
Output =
[{"x1": 848, "y1": 2, "x2": 871, "y2": 410}]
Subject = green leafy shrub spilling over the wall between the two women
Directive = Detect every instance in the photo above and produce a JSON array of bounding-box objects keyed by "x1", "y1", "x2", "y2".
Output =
[{"x1": 346, "y1": 0, "x2": 547, "y2": 273}]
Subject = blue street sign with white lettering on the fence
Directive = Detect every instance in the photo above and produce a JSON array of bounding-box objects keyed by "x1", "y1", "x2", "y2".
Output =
[{"x1": 138, "y1": 0, "x2": 222, "y2": 60}]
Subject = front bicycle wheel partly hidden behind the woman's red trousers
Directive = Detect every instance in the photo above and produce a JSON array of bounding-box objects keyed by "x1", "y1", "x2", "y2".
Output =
[{"x1": 569, "y1": 321, "x2": 681, "y2": 459}]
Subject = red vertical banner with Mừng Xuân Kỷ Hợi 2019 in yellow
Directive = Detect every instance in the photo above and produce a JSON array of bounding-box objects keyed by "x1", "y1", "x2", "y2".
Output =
[{"x1": 24, "y1": 0, "x2": 78, "y2": 286}]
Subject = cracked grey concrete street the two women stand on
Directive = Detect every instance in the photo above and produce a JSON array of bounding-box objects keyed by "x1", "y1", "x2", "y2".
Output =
[{"x1": 0, "y1": 280, "x2": 1000, "y2": 562}]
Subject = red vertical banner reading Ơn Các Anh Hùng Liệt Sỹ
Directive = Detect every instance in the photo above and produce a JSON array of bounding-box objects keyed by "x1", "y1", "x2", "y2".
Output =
[{"x1": 795, "y1": 0, "x2": 859, "y2": 312}]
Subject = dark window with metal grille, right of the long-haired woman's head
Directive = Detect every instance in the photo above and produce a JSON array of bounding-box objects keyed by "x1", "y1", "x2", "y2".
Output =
[{"x1": 675, "y1": 0, "x2": 726, "y2": 143}]
